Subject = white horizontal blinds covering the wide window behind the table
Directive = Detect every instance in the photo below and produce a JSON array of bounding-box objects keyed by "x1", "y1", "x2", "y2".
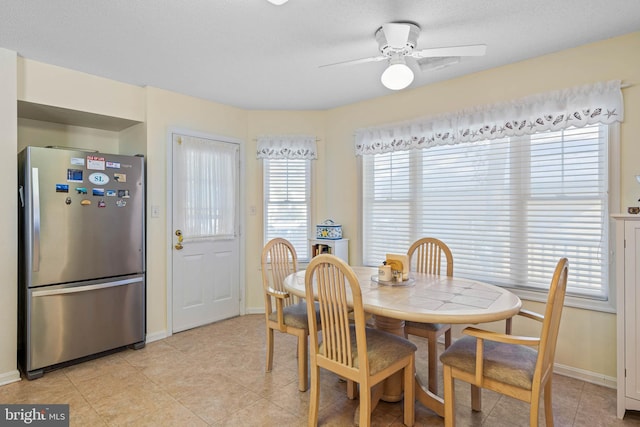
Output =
[{"x1": 362, "y1": 125, "x2": 608, "y2": 299}]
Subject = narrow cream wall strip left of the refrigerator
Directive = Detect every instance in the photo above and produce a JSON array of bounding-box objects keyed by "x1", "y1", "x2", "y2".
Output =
[{"x1": 0, "y1": 48, "x2": 20, "y2": 385}]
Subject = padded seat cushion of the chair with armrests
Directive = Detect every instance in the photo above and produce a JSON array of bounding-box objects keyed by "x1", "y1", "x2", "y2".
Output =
[{"x1": 440, "y1": 336, "x2": 538, "y2": 390}]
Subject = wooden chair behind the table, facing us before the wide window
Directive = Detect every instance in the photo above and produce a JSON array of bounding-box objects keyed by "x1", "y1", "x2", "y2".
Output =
[{"x1": 404, "y1": 237, "x2": 453, "y2": 394}]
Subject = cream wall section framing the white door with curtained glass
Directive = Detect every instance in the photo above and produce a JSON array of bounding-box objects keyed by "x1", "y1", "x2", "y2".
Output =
[{"x1": 146, "y1": 88, "x2": 247, "y2": 339}]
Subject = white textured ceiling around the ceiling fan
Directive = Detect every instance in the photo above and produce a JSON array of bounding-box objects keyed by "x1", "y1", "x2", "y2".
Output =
[{"x1": 0, "y1": 0, "x2": 640, "y2": 110}]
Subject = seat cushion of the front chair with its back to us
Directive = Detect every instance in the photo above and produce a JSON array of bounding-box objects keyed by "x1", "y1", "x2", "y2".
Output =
[{"x1": 319, "y1": 326, "x2": 417, "y2": 375}]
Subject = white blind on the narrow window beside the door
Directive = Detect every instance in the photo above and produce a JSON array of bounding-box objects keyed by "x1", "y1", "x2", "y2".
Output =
[{"x1": 264, "y1": 159, "x2": 311, "y2": 261}]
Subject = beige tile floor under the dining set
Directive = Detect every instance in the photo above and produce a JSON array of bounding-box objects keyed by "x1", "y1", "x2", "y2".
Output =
[{"x1": 0, "y1": 315, "x2": 640, "y2": 427}]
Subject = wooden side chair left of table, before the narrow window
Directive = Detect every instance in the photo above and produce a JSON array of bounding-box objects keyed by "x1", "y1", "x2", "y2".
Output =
[{"x1": 262, "y1": 238, "x2": 317, "y2": 391}]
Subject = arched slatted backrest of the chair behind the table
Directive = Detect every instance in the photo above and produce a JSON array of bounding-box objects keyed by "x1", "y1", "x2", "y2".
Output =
[{"x1": 407, "y1": 237, "x2": 453, "y2": 276}]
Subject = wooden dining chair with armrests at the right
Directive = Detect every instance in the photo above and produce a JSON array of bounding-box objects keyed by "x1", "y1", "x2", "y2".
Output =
[{"x1": 440, "y1": 258, "x2": 568, "y2": 427}]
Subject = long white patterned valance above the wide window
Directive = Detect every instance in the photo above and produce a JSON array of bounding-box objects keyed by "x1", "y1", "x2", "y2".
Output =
[{"x1": 355, "y1": 80, "x2": 624, "y2": 156}]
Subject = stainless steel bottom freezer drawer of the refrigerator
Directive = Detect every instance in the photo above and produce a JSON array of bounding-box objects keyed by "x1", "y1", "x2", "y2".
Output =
[{"x1": 25, "y1": 276, "x2": 145, "y2": 372}]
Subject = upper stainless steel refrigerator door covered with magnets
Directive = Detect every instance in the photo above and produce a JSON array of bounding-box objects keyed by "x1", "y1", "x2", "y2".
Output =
[{"x1": 20, "y1": 147, "x2": 145, "y2": 287}]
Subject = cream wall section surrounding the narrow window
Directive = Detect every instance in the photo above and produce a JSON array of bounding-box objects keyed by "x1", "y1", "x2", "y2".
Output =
[{"x1": 245, "y1": 111, "x2": 327, "y2": 313}]
